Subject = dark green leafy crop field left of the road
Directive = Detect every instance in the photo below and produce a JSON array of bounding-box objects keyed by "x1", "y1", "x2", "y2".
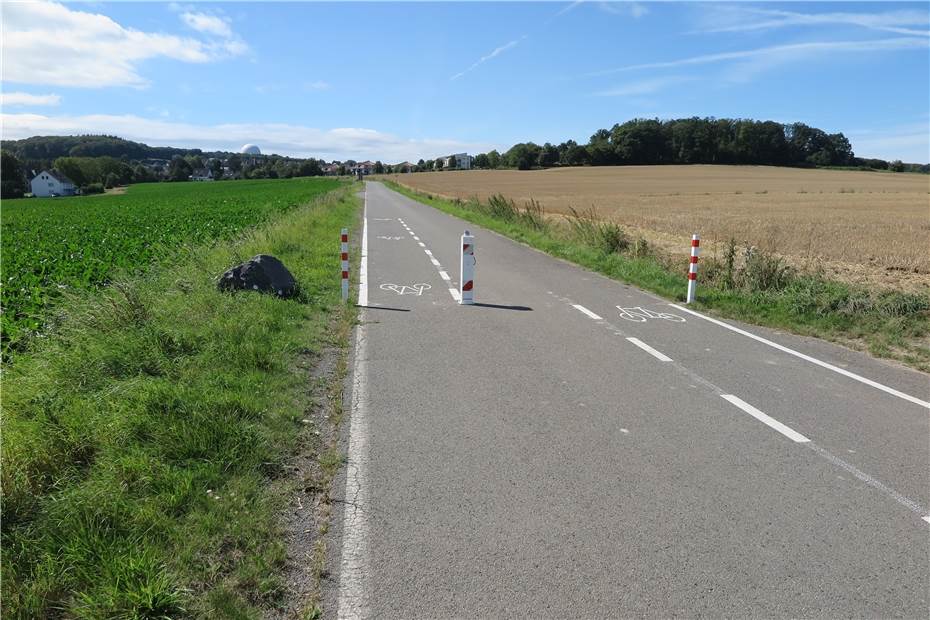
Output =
[{"x1": 0, "y1": 178, "x2": 339, "y2": 350}]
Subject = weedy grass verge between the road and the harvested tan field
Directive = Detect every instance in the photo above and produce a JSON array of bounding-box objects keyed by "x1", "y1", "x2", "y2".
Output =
[{"x1": 385, "y1": 181, "x2": 930, "y2": 372}]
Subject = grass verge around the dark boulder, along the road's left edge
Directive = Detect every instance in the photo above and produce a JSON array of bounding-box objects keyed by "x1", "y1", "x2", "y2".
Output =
[{"x1": 0, "y1": 179, "x2": 361, "y2": 618}]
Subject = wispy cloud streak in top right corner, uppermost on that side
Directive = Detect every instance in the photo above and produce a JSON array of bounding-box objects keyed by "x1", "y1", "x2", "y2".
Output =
[{"x1": 701, "y1": 6, "x2": 930, "y2": 36}]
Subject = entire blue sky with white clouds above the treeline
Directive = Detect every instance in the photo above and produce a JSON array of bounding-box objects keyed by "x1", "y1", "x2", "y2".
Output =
[{"x1": 2, "y1": 2, "x2": 930, "y2": 163}]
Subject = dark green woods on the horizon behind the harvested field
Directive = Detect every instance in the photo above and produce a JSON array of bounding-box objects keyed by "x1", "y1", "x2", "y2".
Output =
[{"x1": 468, "y1": 118, "x2": 930, "y2": 172}]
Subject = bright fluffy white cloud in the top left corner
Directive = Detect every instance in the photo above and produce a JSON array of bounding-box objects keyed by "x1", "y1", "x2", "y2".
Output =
[{"x1": 2, "y1": 2, "x2": 247, "y2": 88}]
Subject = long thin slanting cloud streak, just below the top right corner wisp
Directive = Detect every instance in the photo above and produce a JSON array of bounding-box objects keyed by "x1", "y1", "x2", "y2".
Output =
[{"x1": 585, "y1": 37, "x2": 928, "y2": 77}]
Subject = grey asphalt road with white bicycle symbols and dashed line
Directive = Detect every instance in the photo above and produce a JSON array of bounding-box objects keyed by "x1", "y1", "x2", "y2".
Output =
[{"x1": 325, "y1": 182, "x2": 930, "y2": 618}]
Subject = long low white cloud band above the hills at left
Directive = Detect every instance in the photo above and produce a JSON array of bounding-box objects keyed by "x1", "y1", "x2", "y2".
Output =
[{"x1": 2, "y1": 113, "x2": 492, "y2": 162}]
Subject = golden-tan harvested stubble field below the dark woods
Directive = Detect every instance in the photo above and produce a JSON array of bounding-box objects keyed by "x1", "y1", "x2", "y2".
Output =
[{"x1": 390, "y1": 166, "x2": 930, "y2": 290}]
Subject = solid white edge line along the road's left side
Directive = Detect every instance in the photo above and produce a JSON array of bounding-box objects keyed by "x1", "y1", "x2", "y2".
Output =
[{"x1": 336, "y1": 194, "x2": 370, "y2": 619}]
